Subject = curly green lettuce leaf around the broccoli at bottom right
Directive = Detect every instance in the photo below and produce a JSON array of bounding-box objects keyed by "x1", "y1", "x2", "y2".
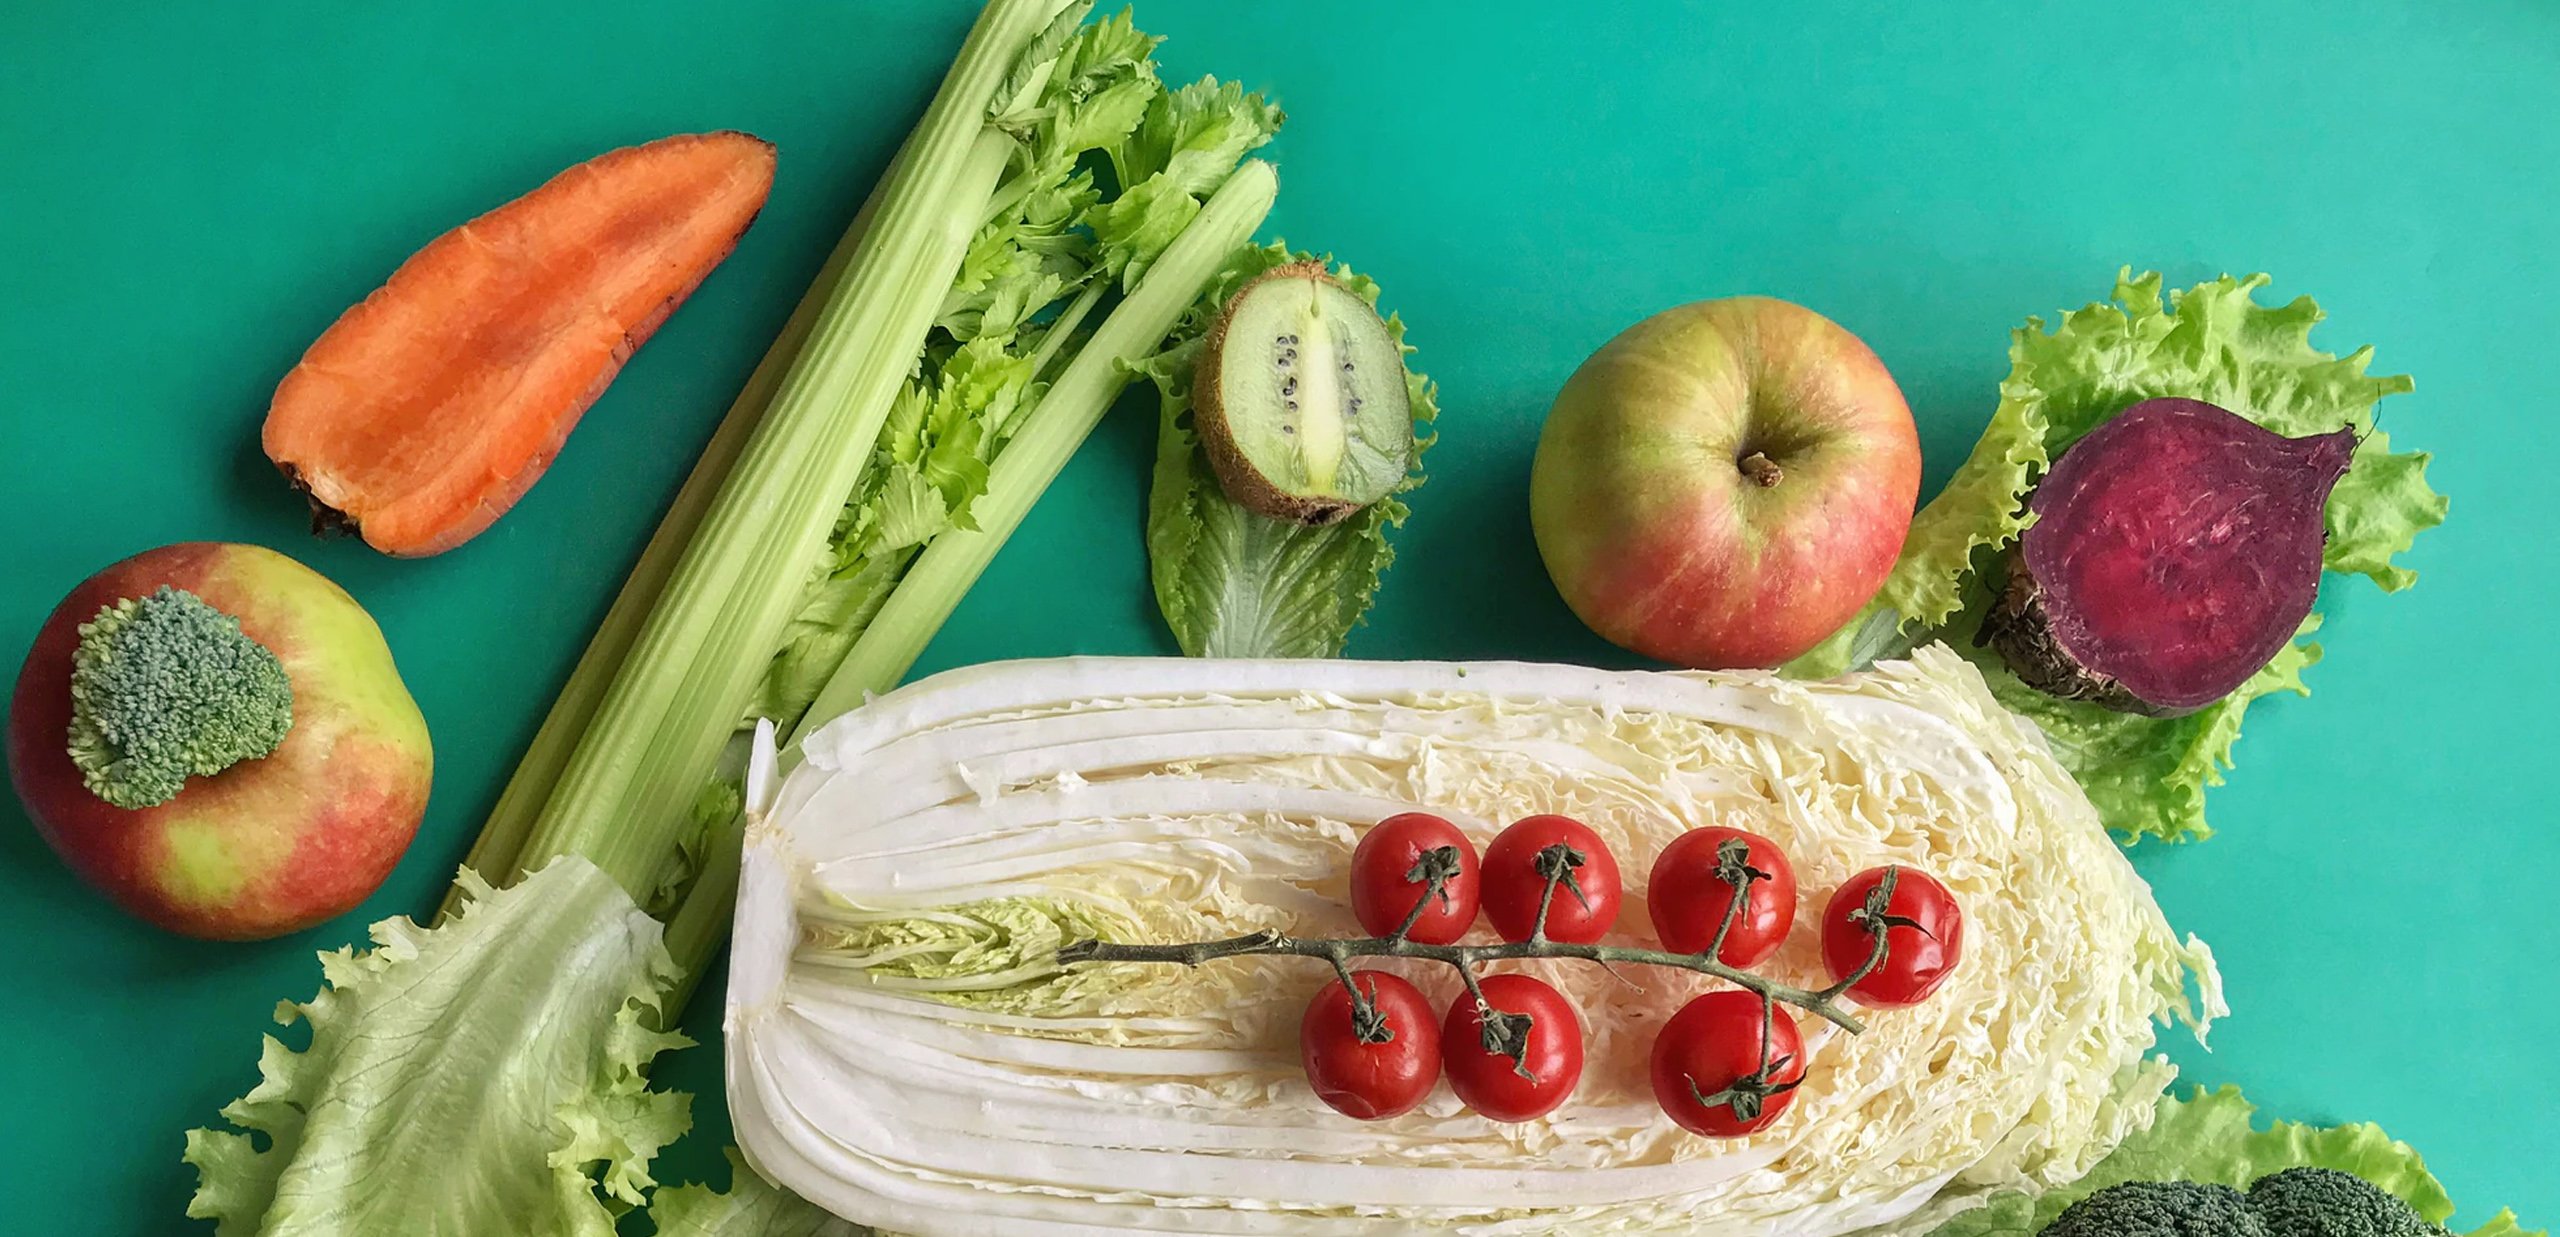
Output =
[{"x1": 1928, "y1": 1086, "x2": 2542, "y2": 1237}]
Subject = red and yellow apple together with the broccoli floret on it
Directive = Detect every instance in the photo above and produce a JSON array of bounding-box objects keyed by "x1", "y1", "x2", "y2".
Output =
[{"x1": 8, "y1": 543, "x2": 433, "y2": 940}]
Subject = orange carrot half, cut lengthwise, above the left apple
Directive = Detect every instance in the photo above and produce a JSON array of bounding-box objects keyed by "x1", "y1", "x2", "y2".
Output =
[{"x1": 264, "y1": 133, "x2": 773, "y2": 556}]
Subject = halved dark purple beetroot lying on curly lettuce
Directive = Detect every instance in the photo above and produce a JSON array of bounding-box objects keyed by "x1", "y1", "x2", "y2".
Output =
[{"x1": 1981, "y1": 400, "x2": 2355, "y2": 717}]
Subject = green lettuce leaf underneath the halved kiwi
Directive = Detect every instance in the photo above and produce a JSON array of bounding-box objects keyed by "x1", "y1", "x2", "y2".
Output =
[{"x1": 1139, "y1": 246, "x2": 1439, "y2": 658}]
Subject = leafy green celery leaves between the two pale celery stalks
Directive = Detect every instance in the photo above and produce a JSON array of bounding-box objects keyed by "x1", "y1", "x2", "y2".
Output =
[{"x1": 748, "y1": 10, "x2": 1283, "y2": 732}]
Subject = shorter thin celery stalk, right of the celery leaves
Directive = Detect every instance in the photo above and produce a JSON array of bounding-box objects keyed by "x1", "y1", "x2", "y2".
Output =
[{"x1": 794, "y1": 159, "x2": 1280, "y2": 743}]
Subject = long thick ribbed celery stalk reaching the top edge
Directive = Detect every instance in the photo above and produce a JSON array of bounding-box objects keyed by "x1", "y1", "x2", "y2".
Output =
[{"x1": 499, "y1": 0, "x2": 1070, "y2": 896}]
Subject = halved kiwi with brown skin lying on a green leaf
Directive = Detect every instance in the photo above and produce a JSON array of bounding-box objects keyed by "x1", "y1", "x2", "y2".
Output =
[{"x1": 1190, "y1": 261, "x2": 1413, "y2": 525}]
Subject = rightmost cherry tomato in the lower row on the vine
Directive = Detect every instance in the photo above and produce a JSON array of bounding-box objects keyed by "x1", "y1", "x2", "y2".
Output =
[{"x1": 1654, "y1": 989, "x2": 1805, "y2": 1137}]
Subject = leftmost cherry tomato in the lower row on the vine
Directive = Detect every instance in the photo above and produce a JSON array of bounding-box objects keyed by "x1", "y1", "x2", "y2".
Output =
[{"x1": 1298, "y1": 971, "x2": 1441, "y2": 1122}]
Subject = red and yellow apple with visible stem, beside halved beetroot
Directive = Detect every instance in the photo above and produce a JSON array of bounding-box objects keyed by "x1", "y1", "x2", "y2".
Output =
[{"x1": 1528, "y1": 297, "x2": 1920, "y2": 668}]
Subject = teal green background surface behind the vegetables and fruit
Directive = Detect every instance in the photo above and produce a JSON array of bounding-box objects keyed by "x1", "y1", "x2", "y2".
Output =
[{"x1": 0, "y1": 0, "x2": 2560, "y2": 1234}]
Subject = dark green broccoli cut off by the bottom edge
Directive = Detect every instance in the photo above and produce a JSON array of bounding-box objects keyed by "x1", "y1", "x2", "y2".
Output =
[{"x1": 2038, "y1": 1168, "x2": 2450, "y2": 1237}]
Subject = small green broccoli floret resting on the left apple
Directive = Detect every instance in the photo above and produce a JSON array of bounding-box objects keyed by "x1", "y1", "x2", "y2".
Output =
[{"x1": 72, "y1": 584, "x2": 294, "y2": 809}]
